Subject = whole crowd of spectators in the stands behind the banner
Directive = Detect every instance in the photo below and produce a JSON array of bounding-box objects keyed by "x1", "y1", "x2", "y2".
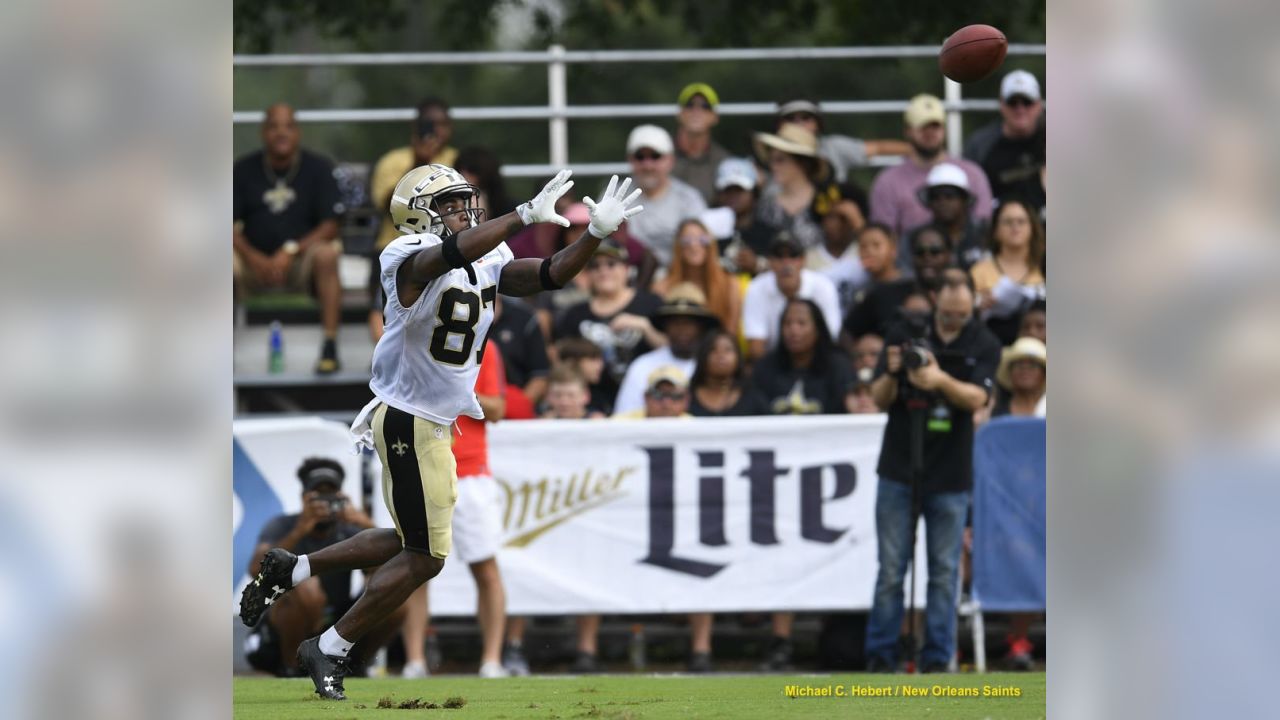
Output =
[{"x1": 234, "y1": 70, "x2": 1047, "y2": 669}]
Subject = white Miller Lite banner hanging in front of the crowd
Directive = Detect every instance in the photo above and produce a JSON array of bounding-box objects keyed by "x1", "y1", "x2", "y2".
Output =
[{"x1": 419, "y1": 415, "x2": 925, "y2": 615}]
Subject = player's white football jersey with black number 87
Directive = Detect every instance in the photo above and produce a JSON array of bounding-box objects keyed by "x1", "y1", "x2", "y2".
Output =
[{"x1": 369, "y1": 233, "x2": 515, "y2": 425}]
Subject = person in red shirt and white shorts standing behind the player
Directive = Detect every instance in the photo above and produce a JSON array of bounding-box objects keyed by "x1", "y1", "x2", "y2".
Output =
[{"x1": 404, "y1": 340, "x2": 509, "y2": 678}]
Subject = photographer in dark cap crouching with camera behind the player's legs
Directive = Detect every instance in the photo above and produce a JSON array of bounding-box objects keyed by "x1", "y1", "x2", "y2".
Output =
[{"x1": 244, "y1": 457, "x2": 404, "y2": 678}]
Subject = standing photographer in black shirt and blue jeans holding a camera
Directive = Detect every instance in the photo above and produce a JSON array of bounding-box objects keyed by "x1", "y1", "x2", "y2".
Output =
[{"x1": 865, "y1": 268, "x2": 1000, "y2": 673}]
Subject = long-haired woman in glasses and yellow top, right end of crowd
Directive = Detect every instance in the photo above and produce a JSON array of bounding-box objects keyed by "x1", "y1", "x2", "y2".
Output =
[{"x1": 970, "y1": 200, "x2": 1044, "y2": 345}]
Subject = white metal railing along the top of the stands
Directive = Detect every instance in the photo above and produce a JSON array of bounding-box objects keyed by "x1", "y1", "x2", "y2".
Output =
[{"x1": 232, "y1": 44, "x2": 1046, "y2": 177}]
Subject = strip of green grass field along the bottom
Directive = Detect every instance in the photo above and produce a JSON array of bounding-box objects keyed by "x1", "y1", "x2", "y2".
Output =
[{"x1": 234, "y1": 673, "x2": 1044, "y2": 720}]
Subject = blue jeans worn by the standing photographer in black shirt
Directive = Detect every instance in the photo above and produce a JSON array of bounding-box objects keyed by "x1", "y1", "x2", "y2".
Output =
[{"x1": 865, "y1": 478, "x2": 969, "y2": 666}]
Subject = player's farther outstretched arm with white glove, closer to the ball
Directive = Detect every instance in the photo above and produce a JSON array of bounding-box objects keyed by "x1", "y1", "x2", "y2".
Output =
[{"x1": 498, "y1": 176, "x2": 644, "y2": 296}]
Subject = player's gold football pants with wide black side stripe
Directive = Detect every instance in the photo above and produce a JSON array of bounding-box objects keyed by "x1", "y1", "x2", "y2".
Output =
[{"x1": 372, "y1": 402, "x2": 458, "y2": 560}]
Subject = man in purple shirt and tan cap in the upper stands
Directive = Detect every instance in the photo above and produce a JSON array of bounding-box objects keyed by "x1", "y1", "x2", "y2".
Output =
[{"x1": 870, "y1": 95, "x2": 991, "y2": 251}]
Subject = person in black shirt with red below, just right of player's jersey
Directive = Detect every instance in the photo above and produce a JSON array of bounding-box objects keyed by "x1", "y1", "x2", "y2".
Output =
[{"x1": 489, "y1": 293, "x2": 550, "y2": 420}]
